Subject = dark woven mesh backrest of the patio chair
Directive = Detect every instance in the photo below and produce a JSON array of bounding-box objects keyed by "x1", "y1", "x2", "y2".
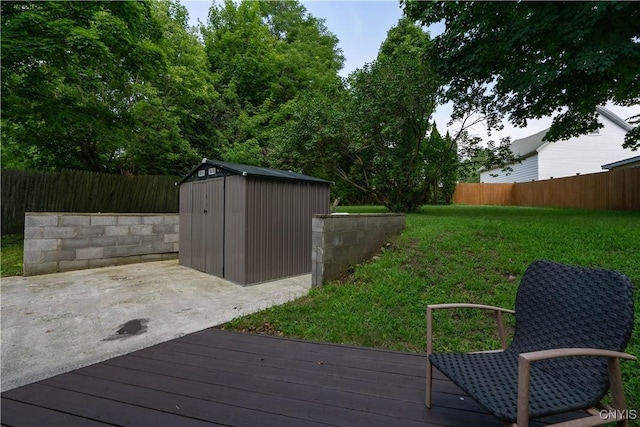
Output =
[{"x1": 512, "y1": 261, "x2": 634, "y2": 353}]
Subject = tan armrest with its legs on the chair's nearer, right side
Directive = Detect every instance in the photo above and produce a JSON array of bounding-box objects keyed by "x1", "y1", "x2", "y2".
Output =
[{"x1": 517, "y1": 348, "x2": 638, "y2": 426}]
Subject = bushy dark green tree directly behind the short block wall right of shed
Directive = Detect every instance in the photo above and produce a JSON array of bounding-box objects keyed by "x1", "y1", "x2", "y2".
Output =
[{"x1": 268, "y1": 20, "x2": 440, "y2": 212}]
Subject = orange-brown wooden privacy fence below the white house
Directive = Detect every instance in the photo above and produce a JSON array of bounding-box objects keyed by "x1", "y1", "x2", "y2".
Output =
[{"x1": 453, "y1": 168, "x2": 640, "y2": 211}]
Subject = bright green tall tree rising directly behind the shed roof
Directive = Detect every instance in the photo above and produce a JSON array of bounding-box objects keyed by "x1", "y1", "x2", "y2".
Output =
[{"x1": 201, "y1": 0, "x2": 344, "y2": 164}]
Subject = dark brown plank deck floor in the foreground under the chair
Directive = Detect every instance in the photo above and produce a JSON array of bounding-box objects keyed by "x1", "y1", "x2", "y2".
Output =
[{"x1": 1, "y1": 329, "x2": 584, "y2": 427}]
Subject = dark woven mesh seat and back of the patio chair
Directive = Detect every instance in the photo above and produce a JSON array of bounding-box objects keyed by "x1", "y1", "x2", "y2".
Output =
[{"x1": 430, "y1": 261, "x2": 634, "y2": 422}]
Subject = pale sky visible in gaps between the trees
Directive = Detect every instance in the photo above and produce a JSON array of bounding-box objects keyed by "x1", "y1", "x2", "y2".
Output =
[{"x1": 181, "y1": 0, "x2": 640, "y2": 145}]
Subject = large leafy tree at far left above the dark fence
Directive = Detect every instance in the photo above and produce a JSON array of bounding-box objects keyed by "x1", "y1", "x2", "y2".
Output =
[{"x1": 1, "y1": 1, "x2": 201, "y2": 174}]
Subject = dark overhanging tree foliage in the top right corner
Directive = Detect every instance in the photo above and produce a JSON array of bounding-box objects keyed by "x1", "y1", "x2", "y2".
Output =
[{"x1": 401, "y1": 0, "x2": 640, "y2": 149}]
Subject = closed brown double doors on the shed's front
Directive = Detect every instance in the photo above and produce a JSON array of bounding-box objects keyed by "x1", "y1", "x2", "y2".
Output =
[{"x1": 191, "y1": 178, "x2": 224, "y2": 277}]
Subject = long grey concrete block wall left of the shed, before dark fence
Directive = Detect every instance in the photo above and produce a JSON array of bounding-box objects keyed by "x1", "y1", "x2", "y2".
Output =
[{"x1": 24, "y1": 212, "x2": 178, "y2": 276}]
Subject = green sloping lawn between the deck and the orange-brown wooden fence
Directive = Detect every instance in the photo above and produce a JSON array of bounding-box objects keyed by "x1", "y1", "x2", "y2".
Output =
[{"x1": 222, "y1": 206, "x2": 640, "y2": 422}]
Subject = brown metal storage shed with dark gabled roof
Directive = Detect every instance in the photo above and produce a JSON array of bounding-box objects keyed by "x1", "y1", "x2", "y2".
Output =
[{"x1": 179, "y1": 159, "x2": 331, "y2": 285}]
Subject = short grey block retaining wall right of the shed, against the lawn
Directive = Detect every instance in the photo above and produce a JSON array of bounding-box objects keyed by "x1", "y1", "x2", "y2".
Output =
[{"x1": 311, "y1": 214, "x2": 405, "y2": 286}]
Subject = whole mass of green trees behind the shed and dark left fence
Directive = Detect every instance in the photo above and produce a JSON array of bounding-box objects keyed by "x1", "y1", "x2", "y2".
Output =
[{"x1": 0, "y1": 0, "x2": 524, "y2": 211}]
